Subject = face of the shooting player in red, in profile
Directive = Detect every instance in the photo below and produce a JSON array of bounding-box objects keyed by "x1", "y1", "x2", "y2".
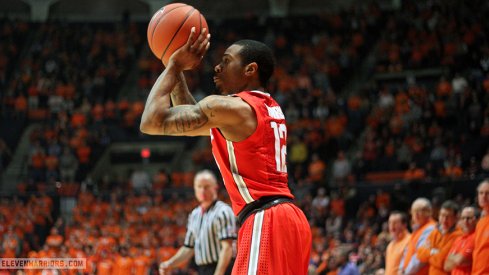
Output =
[{"x1": 214, "y1": 45, "x2": 246, "y2": 94}]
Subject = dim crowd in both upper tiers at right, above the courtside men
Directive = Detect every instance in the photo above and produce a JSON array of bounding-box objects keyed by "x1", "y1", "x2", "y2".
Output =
[{"x1": 351, "y1": 1, "x2": 489, "y2": 181}]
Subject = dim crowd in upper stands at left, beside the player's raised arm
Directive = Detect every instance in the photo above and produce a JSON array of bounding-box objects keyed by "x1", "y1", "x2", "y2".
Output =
[{"x1": 1, "y1": 22, "x2": 147, "y2": 193}]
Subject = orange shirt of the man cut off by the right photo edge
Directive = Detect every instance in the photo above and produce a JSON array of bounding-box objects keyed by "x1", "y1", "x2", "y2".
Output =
[{"x1": 472, "y1": 216, "x2": 489, "y2": 275}]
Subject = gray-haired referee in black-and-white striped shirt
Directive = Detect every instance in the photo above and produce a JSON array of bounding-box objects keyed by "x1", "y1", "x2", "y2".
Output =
[{"x1": 159, "y1": 170, "x2": 236, "y2": 275}]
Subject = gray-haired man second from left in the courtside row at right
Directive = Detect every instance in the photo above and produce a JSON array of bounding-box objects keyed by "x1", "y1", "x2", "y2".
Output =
[{"x1": 398, "y1": 198, "x2": 436, "y2": 275}]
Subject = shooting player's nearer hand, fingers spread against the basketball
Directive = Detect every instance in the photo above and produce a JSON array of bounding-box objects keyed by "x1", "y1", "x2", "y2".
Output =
[{"x1": 168, "y1": 27, "x2": 211, "y2": 71}]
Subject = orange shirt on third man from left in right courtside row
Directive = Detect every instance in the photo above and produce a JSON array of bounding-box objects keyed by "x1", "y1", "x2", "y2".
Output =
[{"x1": 418, "y1": 228, "x2": 463, "y2": 275}]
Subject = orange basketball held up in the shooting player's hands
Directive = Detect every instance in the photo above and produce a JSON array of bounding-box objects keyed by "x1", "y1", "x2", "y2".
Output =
[{"x1": 148, "y1": 3, "x2": 208, "y2": 66}]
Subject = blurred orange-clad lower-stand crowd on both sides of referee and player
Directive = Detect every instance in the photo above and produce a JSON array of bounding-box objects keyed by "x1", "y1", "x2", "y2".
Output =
[{"x1": 0, "y1": 171, "x2": 480, "y2": 274}]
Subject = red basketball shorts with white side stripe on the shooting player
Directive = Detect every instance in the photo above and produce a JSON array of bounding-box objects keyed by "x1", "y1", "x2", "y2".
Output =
[{"x1": 232, "y1": 203, "x2": 312, "y2": 275}]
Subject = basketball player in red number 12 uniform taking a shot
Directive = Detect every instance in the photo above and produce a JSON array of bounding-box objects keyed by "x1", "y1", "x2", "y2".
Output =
[{"x1": 140, "y1": 29, "x2": 311, "y2": 274}]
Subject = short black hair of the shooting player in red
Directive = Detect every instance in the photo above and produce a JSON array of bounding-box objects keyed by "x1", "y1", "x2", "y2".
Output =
[{"x1": 234, "y1": 39, "x2": 275, "y2": 86}]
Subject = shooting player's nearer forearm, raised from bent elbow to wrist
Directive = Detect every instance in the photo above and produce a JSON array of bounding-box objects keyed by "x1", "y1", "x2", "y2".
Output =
[{"x1": 140, "y1": 64, "x2": 180, "y2": 134}]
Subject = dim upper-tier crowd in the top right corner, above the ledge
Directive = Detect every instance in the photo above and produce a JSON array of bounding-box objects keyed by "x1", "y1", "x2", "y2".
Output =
[{"x1": 376, "y1": 0, "x2": 487, "y2": 72}]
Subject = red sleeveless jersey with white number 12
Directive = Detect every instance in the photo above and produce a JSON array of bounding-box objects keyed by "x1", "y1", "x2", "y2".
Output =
[{"x1": 211, "y1": 91, "x2": 294, "y2": 215}]
